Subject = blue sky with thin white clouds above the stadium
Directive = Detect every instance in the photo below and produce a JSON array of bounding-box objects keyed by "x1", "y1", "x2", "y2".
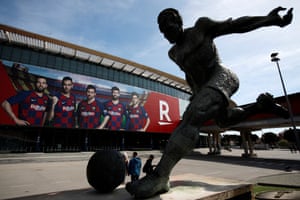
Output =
[{"x1": 0, "y1": 0, "x2": 300, "y2": 134}]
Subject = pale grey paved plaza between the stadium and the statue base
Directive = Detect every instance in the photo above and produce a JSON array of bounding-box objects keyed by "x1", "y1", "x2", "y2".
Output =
[{"x1": 0, "y1": 148, "x2": 300, "y2": 199}]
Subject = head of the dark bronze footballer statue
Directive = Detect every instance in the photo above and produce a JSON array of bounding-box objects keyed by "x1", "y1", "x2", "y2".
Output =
[{"x1": 157, "y1": 8, "x2": 183, "y2": 43}]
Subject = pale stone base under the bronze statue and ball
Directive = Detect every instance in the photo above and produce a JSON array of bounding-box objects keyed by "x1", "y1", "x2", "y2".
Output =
[{"x1": 17, "y1": 174, "x2": 253, "y2": 200}]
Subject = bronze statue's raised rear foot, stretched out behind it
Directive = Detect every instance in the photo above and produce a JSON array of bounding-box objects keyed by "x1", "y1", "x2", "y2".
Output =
[{"x1": 256, "y1": 93, "x2": 289, "y2": 119}]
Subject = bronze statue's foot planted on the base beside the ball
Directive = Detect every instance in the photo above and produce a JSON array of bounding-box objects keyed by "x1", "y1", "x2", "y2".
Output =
[{"x1": 126, "y1": 174, "x2": 170, "y2": 199}]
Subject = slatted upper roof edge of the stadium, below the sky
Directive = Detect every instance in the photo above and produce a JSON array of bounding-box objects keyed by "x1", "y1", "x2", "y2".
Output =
[{"x1": 0, "y1": 24, "x2": 191, "y2": 93}]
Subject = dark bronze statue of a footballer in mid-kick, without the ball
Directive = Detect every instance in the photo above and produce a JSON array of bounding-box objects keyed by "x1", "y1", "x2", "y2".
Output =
[{"x1": 126, "y1": 7, "x2": 293, "y2": 198}]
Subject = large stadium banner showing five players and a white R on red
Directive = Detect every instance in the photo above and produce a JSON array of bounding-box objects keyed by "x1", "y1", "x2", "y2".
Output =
[{"x1": 0, "y1": 61, "x2": 187, "y2": 133}]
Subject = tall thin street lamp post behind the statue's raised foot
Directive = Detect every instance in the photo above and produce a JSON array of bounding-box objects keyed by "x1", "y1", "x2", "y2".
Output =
[{"x1": 271, "y1": 53, "x2": 300, "y2": 149}]
